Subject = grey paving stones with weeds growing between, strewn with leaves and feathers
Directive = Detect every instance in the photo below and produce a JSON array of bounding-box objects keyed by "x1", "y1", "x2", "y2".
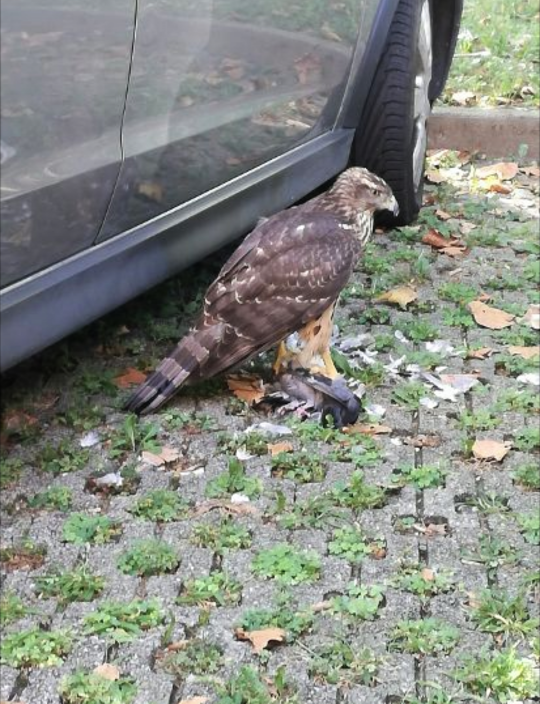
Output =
[{"x1": 0, "y1": 153, "x2": 540, "y2": 704}]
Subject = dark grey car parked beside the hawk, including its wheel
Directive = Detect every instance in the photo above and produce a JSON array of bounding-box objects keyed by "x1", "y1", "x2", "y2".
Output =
[{"x1": 0, "y1": 0, "x2": 462, "y2": 370}]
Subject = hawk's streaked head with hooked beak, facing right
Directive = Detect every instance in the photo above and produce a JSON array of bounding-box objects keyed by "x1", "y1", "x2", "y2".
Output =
[{"x1": 325, "y1": 166, "x2": 399, "y2": 221}]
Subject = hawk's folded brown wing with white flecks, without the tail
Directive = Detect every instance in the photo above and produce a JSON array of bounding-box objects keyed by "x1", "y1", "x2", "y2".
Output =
[{"x1": 192, "y1": 206, "x2": 360, "y2": 376}]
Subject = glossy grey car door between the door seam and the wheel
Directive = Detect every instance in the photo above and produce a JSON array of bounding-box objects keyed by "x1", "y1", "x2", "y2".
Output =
[{"x1": 95, "y1": 0, "x2": 370, "y2": 240}]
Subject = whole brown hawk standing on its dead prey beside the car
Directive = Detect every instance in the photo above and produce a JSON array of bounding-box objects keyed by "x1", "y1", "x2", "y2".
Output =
[{"x1": 125, "y1": 167, "x2": 398, "y2": 413}]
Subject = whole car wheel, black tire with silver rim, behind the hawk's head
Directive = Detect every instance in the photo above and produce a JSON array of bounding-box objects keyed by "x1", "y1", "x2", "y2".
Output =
[{"x1": 353, "y1": 0, "x2": 433, "y2": 224}]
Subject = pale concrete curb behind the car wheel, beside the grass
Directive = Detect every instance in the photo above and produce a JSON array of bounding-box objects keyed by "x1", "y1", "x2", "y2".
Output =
[{"x1": 428, "y1": 107, "x2": 540, "y2": 159}]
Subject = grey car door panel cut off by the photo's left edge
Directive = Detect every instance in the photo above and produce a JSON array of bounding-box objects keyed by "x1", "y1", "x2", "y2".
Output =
[{"x1": 0, "y1": 0, "x2": 136, "y2": 286}]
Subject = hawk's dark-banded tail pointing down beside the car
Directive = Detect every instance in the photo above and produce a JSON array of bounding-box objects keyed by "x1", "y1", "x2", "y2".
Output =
[{"x1": 124, "y1": 325, "x2": 222, "y2": 414}]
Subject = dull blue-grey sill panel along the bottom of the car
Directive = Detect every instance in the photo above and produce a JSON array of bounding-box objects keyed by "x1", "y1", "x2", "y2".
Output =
[{"x1": 0, "y1": 130, "x2": 354, "y2": 369}]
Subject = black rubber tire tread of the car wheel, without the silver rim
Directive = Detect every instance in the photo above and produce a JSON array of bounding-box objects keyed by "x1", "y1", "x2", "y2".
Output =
[{"x1": 352, "y1": 0, "x2": 429, "y2": 225}]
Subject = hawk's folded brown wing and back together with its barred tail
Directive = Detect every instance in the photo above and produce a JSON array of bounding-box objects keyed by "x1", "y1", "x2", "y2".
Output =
[{"x1": 127, "y1": 208, "x2": 360, "y2": 411}]
